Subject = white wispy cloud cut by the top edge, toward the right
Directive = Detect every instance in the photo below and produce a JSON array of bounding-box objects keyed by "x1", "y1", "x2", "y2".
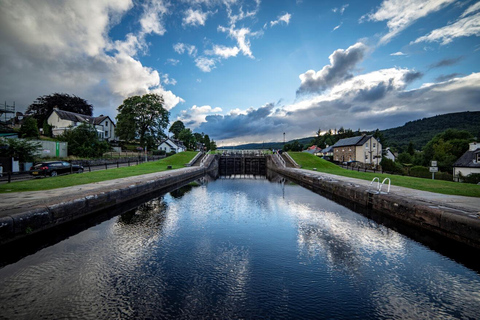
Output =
[{"x1": 366, "y1": 0, "x2": 455, "y2": 44}]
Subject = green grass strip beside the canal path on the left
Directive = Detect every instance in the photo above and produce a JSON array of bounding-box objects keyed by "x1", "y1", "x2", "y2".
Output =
[{"x1": 0, "y1": 151, "x2": 197, "y2": 193}]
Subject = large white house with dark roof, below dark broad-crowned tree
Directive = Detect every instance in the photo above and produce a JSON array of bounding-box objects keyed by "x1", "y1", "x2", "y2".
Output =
[{"x1": 47, "y1": 108, "x2": 115, "y2": 141}]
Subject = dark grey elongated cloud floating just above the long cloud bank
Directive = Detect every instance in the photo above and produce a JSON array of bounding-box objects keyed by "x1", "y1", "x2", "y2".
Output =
[{"x1": 297, "y1": 42, "x2": 368, "y2": 94}]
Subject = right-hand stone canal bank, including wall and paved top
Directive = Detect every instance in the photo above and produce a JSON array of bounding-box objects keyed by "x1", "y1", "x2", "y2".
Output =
[{"x1": 268, "y1": 155, "x2": 480, "y2": 249}]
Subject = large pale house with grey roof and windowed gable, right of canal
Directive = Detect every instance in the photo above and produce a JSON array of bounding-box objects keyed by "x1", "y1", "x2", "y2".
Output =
[{"x1": 332, "y1": 135, "x2": 382, "y2": 165}]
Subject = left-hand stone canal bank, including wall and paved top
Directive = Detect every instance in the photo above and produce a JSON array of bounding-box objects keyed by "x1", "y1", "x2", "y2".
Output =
[{"x1": 0, "y1": 155, "x2": 218, "y2": 244}]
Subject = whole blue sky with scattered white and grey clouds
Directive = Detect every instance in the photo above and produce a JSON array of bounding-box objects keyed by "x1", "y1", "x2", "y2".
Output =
[{"x1": 0, "y1": 0, "x2": 480, "y2": 146}]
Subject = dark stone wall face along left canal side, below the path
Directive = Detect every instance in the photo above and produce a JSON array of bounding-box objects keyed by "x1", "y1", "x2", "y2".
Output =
[{"x1": 0, "y1": 157, "x2": 218, "y2": 244}]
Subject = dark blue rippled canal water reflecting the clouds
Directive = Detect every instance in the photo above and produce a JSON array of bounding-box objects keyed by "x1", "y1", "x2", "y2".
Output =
[{"x1": 0, "y1": 178, "x2": 480, "y2": 319}]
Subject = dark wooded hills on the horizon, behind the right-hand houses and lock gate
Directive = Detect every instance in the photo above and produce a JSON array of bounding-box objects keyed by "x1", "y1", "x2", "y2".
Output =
[{"x1": 223, "y1": 111, "x2": 480, "y2": 150}]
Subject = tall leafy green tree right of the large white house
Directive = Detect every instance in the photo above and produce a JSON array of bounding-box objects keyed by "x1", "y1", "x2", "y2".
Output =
[{"x1": 116, "y1": 93, "x2": 170, "y2": 147}]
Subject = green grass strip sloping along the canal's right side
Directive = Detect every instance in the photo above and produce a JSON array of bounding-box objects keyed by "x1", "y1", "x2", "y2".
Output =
[{"x1": 288, "y1": 152, "x2": 480, "y2": 197}]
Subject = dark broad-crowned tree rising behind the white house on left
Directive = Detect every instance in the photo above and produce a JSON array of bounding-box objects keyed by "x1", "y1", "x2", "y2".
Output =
[{"x1": 26, "y1": 93, "x2": 93, "y2": 124}]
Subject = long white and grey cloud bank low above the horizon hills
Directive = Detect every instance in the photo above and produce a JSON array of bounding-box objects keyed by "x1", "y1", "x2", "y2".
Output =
[{"x1": 199, "y1": 68, "x2": 480, "y2": 144}]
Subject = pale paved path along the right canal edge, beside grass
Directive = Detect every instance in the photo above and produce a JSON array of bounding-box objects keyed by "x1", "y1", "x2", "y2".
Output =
[{"x1": 291, "y1": 169, "x2": 480, "y2": 218}]
